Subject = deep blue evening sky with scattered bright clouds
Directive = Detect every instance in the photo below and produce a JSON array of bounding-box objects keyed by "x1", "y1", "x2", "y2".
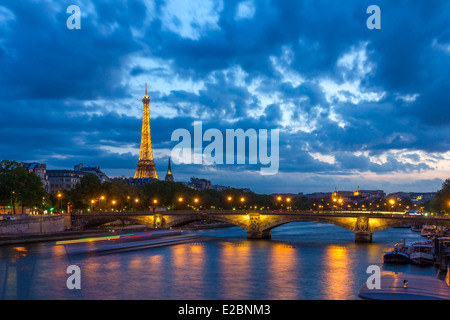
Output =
[{"x1": 0, "y1": 0, "x2": 450, "y2": 193}]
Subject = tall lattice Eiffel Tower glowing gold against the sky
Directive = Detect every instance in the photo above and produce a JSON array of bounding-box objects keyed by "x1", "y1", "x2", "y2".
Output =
[{"x1": 134, "y1": 84, "x2": 158, "y2": 179}]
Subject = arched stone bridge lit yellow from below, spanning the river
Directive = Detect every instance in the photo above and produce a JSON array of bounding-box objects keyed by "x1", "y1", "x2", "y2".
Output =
[{"x1": 67, "y1": 211, "x2": 450, "y2": 242}]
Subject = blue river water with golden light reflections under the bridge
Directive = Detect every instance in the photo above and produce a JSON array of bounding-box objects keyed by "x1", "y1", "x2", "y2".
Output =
[{"x1": 0, "y1": 223, "x2": 437, "y2": 300}]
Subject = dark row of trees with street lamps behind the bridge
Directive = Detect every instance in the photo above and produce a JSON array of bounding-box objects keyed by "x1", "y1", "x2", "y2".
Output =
[{"x1": 0, "y1": 160, "x2": 450, "y2": 214}]
